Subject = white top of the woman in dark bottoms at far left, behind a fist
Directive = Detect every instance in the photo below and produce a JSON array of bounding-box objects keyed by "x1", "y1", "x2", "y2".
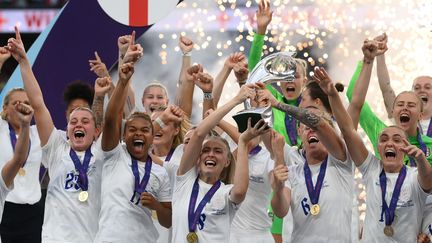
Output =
[{"x1": 0, "y1": 118, "x2": 42, "y2": 204}]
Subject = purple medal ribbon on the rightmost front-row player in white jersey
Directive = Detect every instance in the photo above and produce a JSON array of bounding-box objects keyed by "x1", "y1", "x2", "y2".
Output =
[{"x1": 380, "y1": 165, "x2": 406, "y2": 226}]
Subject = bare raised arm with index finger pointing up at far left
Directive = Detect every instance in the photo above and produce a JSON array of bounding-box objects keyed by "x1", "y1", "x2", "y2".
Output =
[{"x1": 6, "y1": 26, "x2": 54, "y2": 147}]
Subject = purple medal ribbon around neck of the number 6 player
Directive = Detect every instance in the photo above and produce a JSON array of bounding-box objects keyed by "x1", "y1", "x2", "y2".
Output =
[{"x1": 303, "y1": 157, "x2": 327, "y2": 205}]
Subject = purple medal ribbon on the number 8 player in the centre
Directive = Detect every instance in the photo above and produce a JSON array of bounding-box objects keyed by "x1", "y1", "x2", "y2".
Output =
[{"x1": 188, "y1": 177, "x2": 221, "y2": 232}]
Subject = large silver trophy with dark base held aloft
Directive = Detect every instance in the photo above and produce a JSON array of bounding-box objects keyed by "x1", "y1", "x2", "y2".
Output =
[{"x1": 233, "y1": 52, "x2": 297, "y2": 132}]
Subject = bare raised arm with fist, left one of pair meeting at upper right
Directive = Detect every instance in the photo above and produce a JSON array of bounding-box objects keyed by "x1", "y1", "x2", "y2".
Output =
[{"x1": 348, "y1": 40, "x2": 378, "y2": 129}]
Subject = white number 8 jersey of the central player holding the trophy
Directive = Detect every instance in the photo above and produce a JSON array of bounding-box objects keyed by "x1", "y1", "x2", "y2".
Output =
[{"x1": 172, "y1": 168, "x2": 238, "y2": 243}]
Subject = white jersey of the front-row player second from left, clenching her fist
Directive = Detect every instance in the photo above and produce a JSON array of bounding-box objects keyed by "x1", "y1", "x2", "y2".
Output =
[{"x1": 95, "y1": 143, "x2": 171, "y2": 242}]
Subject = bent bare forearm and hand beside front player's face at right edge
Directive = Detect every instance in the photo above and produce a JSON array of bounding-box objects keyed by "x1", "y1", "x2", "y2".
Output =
[{"x1": 401, "y1": 139, "x2": 432, "y2": 193}]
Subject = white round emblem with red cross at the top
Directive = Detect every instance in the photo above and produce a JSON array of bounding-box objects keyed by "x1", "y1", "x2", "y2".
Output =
[{"x1": 98, "y1": 0, "x2": 178, "y2": 27}]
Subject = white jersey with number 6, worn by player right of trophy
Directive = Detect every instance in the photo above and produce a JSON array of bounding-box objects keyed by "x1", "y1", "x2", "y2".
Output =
[{"x1": 285, "y1": 154, "x2": 354, "y2": 242}]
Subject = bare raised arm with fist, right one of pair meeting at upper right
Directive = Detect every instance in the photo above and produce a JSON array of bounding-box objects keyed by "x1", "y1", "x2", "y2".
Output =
[{"x1": 374, "y1": 33, "x2": 396, "y2": 118}]
